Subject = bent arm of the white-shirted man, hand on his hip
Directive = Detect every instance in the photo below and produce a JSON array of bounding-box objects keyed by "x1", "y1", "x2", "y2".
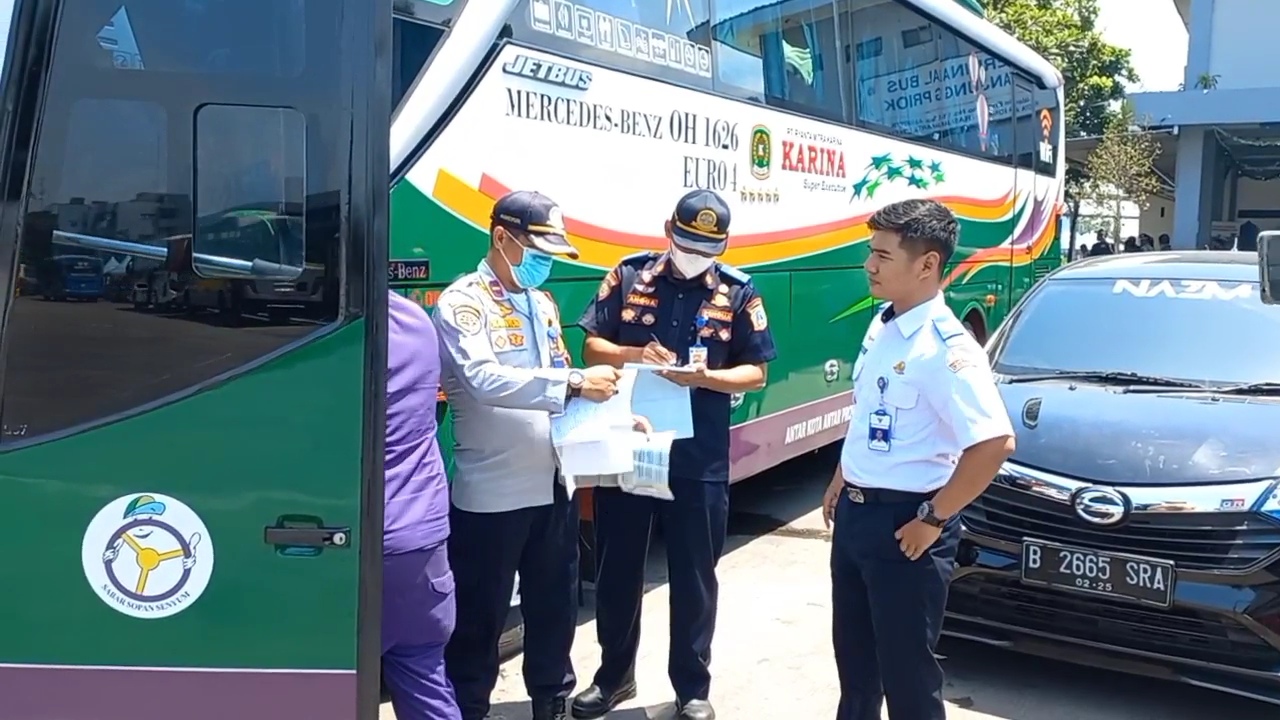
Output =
[{"x1": 929, "y1": 337, "x2": 1014, "y2": 519}]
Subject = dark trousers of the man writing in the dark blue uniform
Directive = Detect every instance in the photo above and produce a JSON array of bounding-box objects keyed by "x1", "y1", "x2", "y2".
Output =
[{"x1": 594, "y1": 478, "x2": 728, "y2": 702}]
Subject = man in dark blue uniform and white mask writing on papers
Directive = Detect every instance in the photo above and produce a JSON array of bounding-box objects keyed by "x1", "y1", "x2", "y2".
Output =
[{"x1": 572, "y1": 190, "x2": 777, "y2": 720}]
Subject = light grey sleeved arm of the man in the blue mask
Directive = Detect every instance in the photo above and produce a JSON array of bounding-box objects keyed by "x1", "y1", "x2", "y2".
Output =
[{"x1": 434, "y1": 285, "x2": 570, "y2": 413}]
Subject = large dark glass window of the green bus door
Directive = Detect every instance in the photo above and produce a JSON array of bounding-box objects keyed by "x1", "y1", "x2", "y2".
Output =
[{"x1": 0, "y1": 0, "x2": 340, "y2": 443}]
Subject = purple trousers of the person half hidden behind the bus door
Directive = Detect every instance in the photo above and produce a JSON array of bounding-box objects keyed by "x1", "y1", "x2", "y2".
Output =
[{"x1": 383, "y1": 542, "x2": 461, "y2": 720}]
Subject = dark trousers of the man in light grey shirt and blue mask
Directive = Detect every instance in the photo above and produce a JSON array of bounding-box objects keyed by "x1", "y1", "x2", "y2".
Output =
[{"x1": 445, "y1": 483, "x2": 577, "y2": 720}]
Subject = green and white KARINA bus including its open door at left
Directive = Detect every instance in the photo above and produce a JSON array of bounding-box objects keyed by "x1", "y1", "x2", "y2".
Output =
[{"x1": 0, "y1": 0, "x2": 1062, "y2": 720}]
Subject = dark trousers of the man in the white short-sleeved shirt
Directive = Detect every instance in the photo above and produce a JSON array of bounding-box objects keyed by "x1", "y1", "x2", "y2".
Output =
[{"x1": 831, "y1": 491, "x2": 960, "y2": 720}]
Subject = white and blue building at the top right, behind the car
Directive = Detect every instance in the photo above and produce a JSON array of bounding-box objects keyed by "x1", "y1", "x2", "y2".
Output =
[{"x1": 1132, "y1": 0, "x2": 1280, "y2": 247}]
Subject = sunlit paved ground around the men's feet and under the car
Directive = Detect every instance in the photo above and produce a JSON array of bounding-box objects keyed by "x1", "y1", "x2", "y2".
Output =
[{"x1": 383, "y1": 445, "x2": 1280, "y2": 720}]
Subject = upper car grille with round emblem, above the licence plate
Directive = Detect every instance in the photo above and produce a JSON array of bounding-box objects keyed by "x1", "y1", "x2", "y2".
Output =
[{"x1": 963, "y1": 484, "x2": 1280, "y2": 570}]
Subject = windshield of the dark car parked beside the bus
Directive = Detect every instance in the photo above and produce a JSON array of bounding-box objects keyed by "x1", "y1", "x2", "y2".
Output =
[{"x1": 993, "y1": 279, "x2": 1280, "y2": 384}]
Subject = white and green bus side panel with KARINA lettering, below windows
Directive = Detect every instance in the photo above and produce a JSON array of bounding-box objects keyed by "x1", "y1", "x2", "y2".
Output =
[{"x1": 390, "y1": 44, "x2": 1061, "y2": 479}]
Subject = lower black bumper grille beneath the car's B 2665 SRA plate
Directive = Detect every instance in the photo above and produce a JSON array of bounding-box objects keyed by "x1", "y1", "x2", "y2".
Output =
[{"x1": 947, "y1": 575, "x2": 1280, "y2": 673}]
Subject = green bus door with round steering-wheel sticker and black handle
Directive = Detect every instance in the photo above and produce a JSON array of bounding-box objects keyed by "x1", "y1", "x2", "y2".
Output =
[{"x1": 0, "y1": 0, "x2": 392, "y2": 720}]
